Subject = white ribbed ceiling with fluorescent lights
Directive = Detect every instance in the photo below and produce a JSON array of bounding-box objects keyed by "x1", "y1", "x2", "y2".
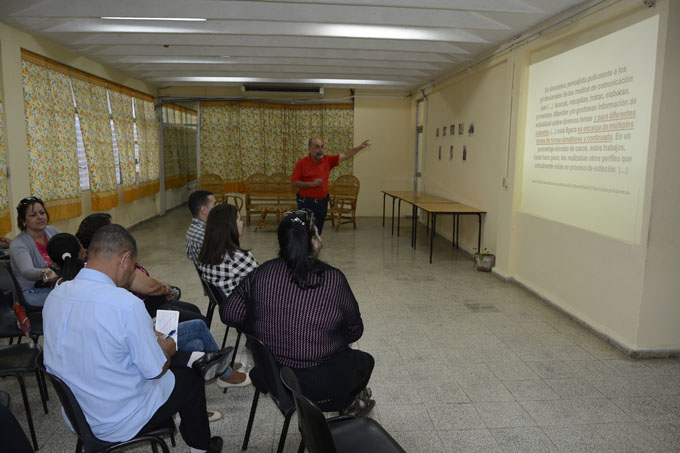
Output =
[{"x1": 0, "y1": 0, "x2": 583, "y2": 90}]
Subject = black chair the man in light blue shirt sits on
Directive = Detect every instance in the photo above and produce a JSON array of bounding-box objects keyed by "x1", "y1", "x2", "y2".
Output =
[{"x1": 40, "y1": 356, "x2": 176, "y2": 453}]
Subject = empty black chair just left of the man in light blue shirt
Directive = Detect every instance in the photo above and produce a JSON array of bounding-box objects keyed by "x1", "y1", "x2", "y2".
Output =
[{"x1": 0, "y1": 343, "x2": 49, "y2": 450}]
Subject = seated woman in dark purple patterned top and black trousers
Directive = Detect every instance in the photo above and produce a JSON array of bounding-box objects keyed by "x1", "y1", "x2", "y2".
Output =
[{"x1": 220, "y1": 209, "x2": 375, "y2": 416}]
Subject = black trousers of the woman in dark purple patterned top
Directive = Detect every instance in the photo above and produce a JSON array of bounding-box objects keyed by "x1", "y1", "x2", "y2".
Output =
[{"x1": 293, "y1": 348, "x2": 375, "y2": 412}]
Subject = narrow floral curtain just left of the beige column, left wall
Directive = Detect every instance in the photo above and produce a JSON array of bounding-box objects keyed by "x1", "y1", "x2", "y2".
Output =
[{"x1": 135, "y1": 97, "x2": 161, "y2": 197}]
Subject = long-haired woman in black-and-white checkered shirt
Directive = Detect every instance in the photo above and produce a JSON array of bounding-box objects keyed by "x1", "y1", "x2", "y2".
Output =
[{"x1": 198, "y1": 204, "x2": 257, "y2": 297}]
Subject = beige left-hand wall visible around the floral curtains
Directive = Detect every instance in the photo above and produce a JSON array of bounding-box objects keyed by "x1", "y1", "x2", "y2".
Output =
[{"x1": 0, "y1": 23, "x2": 194, "y2": 236}]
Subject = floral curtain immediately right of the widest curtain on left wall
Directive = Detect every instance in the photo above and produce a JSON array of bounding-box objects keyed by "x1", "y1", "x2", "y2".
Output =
[{"x1": 72, "y1": 77, "x2": 118, "y2": 211}]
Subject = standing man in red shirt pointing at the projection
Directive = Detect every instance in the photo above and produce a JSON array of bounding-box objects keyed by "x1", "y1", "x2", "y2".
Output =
[{"x1": 290, "y1": 137, "x2": 371, "y2": 234}]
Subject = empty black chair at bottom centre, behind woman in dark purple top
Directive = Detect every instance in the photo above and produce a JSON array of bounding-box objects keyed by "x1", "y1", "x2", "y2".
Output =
[{"x1": 280, "y1": 367, "x2": 405, "y2": 453}]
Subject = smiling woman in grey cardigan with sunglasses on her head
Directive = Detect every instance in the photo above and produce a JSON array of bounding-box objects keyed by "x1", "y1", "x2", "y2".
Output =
[{"x1": 9, "y1": 197, "x2": 59, "y2": 307}]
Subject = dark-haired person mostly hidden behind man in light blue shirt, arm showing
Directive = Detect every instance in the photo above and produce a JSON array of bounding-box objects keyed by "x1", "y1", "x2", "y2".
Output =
[{"x1": 76, "y1": 213, "x2": 205, "y2": 321}]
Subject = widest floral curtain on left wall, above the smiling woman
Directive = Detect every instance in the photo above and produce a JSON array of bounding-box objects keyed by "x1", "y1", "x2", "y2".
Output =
[{"x1": 22, "y1": 52, "x2": 81, "y2": 221}]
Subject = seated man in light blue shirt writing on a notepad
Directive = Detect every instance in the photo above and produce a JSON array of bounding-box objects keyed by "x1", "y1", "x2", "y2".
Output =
[{"x1": 43, "y1": 225, "x2": 222, "y2": 453}]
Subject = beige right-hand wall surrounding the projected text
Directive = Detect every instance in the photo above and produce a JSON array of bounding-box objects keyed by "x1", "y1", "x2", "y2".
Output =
[{"x1": 414, "y1": 0, "x2": 680, "y2": 353}]
